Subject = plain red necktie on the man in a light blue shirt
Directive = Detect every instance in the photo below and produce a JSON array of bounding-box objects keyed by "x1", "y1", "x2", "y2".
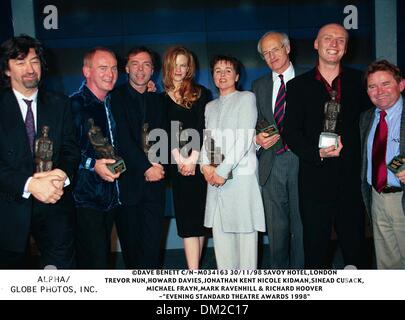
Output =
[{"x1": 372, "y1": 110, "x2": 388, "y2": 192}]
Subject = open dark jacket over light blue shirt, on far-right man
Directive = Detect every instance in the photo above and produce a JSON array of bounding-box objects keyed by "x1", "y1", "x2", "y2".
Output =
[{"x1": 360, "y1": 99, "x2": 405, "y2": 218}]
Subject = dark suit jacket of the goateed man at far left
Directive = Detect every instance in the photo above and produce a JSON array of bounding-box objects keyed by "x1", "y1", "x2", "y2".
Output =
[{"x1": 0, "y1": 89, "x2": 80, "y2": 252}]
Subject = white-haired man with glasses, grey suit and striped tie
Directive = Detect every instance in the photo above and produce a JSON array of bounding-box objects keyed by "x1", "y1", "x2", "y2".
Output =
[{"x1": 252, "y1": 31, "x2": 304, "y2": 269}]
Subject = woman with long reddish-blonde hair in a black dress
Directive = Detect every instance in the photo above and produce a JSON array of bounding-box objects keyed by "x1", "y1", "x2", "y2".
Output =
[{"x1": 163, "y1": 46, "x2": 209, "y2": 269}]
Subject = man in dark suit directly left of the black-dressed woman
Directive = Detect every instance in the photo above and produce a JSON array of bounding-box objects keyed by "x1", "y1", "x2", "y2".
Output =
[{"x1": 111, "y1": 47, "x2": 168, "y2": 269}]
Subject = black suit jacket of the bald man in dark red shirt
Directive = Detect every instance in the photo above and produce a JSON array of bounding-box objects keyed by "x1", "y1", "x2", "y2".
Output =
[{"x1": 284, "y1": 68, "x2": 369, "y2": 202}]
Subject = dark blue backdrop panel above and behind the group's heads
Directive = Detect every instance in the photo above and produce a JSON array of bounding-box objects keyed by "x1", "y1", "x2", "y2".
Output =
[{"x1": 34, "y1": 0, "x2": 374, "y2": 96}]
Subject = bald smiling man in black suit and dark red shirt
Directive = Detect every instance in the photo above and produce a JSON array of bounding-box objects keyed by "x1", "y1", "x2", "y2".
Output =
[{"x1": 284, "y1": 24, "x2": 369, "y2": 269}]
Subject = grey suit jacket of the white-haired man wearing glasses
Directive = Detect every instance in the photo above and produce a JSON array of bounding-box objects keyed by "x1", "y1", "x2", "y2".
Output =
[{"x1": 252, "y1": 65, "x2": 302, "y2": 186}]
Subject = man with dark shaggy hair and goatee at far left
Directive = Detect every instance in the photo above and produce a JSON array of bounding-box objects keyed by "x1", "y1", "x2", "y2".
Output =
[{"x1": 0, "y1": 36, "x2": 80, "y2": 268}]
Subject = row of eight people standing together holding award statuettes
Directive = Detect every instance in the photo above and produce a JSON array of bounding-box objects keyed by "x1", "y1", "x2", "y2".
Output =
[{"x1": 0, "y1": 24, "x2": 405, "y2": 269}]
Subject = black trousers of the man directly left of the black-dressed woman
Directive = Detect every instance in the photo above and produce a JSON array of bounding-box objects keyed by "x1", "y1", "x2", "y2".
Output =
[{"x1": 116, "y1": 199, "x2": 164, "y2": 269}]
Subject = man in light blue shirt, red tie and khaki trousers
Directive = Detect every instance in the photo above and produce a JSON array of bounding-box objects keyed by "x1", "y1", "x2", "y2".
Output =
[{"x1": 360, "y1": 60, "x2": 405, "y2": 269}]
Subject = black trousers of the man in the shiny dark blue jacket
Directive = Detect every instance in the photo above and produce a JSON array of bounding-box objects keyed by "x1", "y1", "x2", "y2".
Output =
[{"x1": 76, "y1": 208, "x2": 117, "y2": 269}]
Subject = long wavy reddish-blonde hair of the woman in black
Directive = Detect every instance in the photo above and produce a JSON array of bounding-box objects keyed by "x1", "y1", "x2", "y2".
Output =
[{"x1": 163, "y1": 46, "x2": 201, "y2": 109}]
